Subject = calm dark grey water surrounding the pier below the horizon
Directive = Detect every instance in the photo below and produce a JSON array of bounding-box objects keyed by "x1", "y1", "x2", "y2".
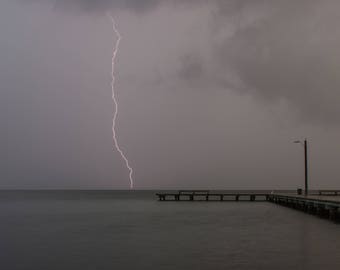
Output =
[{"x1": 0, "y1": 191, "x2": 340, "y2": 270}]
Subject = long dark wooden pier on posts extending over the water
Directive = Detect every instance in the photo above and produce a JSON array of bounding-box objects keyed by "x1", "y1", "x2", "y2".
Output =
[{"x1": 156, "y1": 190, "x2": 340, "y2": 221}]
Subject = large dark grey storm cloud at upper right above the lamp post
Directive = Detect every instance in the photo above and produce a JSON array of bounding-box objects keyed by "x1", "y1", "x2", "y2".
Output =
[{"x1": 215, "y1": 1, "x2": 340, "y2": 123}]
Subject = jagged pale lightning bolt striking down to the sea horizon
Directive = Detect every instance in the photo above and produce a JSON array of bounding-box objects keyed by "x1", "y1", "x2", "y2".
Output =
[{"x1": 107, "y1": 14, "x2": 133, "y2": 189}]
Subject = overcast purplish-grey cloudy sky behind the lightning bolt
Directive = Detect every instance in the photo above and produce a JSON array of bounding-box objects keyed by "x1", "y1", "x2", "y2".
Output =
[{"x1": 0, "y1": 0, "x2": 340, "y2": 189}]
